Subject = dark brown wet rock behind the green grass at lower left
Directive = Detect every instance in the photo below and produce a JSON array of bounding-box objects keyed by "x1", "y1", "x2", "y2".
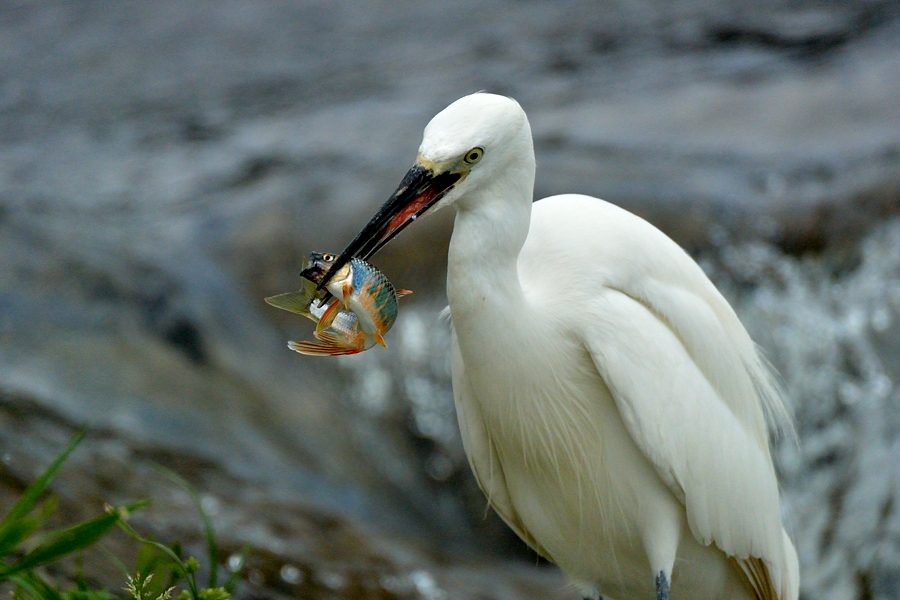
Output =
[{"x1": 0, "y1": 395, "x2": 563, "y2": 600}]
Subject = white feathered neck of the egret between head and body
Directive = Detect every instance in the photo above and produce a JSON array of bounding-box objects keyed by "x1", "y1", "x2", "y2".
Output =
[{"x1": 447, "y1": 155, "x2": 534, "y2": 319}]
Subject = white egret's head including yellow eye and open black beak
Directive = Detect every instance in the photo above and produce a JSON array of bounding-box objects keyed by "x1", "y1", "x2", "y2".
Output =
[{"x1": 320, "y1": 93, "x2": 533, "y2": 286}]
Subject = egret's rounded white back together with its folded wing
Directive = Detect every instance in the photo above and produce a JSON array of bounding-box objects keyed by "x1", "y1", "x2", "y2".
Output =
[{"x1": 519, "y1": 194, "x2": 799, "y2": 600}]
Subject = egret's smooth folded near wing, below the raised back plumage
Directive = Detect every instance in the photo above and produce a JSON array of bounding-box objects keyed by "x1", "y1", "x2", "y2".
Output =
[{"x1": 585, "y1": 289, "x2": 789, "y2": 600}]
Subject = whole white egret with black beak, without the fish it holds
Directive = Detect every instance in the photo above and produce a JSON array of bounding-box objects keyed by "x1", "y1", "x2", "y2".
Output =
[{"x1": 326, "y1": 93, "x2": 799, "y2": 600}]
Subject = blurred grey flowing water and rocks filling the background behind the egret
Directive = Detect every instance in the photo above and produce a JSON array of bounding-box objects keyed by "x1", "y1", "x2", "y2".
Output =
[{"x1": 0, "y1": 0, "x2": 900, "y2": 600}]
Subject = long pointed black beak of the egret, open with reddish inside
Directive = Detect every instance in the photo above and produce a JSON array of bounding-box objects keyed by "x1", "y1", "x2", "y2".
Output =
[{"x1": 316, "y1": 164, "x2": 462, "y2": 289}]
